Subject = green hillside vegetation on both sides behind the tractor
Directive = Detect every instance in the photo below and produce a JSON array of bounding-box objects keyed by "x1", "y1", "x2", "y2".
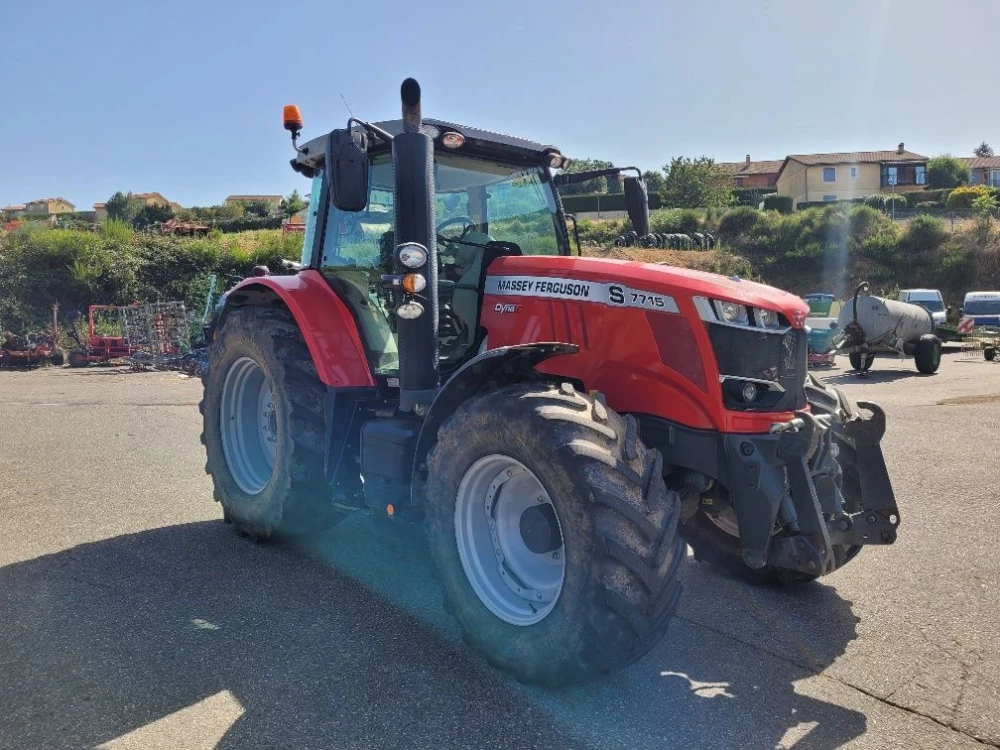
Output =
[{"x1": 0, "y1": 205, "x2": 1000, "y2": 330}]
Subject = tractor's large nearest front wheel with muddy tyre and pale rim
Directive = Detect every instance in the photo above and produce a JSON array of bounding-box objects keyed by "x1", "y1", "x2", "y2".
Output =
[{"x1": 423, "y1": 383, "x2": 685, "y2": 686}]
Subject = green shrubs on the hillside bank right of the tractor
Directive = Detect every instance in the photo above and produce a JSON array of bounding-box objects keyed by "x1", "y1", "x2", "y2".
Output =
[{"x1": 580, "y1": 205, "x2": 1000, "y2": 304}]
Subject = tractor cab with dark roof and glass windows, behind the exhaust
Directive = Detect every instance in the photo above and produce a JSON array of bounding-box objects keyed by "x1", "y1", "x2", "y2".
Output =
[{"x1": 292, "y1": 119, "x2": 648, "y2": 390}]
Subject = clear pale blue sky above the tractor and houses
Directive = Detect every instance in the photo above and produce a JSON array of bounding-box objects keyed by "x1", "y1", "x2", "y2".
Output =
[{"x1": 0, "y1": 0, "x2": 1000, "y2": 209}]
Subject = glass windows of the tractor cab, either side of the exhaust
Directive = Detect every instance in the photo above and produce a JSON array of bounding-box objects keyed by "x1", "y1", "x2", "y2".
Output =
[{"x1": 303, "y1": 154, "x2": 568, "y2": 375}]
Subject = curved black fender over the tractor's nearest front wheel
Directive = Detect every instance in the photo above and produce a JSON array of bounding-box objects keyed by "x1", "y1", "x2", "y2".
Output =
[{"x1": 411, "y1": 343, "x2": 579, "y2": 505}]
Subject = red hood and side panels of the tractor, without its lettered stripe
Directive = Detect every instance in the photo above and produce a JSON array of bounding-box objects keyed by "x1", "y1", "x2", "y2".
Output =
[{"x1": 482, "y1": 256, "x2": 808, "y2": 433}]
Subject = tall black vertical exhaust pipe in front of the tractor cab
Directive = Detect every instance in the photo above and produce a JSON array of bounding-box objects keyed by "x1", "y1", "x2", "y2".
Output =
[{"x1": 392, "y1": 78, "x2": 441, "y2": 414}]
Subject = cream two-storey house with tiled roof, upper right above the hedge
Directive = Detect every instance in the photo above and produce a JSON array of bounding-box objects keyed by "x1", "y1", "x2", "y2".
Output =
[{"x1": 775, "y1": 143, "x2": 927, "y2": 206}]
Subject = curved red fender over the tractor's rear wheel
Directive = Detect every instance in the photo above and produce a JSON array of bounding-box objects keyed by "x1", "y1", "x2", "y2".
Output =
[{"x1": 215, "y1": 270, "x2": 375, "y2": 388}]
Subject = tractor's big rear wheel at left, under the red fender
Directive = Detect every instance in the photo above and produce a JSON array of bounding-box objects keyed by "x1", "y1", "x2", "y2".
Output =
[{"x1": 200, "y1": 307, "x2": 344, "y2": 540}]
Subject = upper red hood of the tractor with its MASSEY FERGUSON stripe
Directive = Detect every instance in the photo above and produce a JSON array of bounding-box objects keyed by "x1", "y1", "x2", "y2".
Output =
[{"x1": 487, "y1": 256, "x2": 809, "y2": 328}]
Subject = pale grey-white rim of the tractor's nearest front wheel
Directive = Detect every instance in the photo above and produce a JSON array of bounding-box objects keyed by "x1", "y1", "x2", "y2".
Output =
[{"x1": 455, "y1": 454, "x2": 566, "y2": 627}]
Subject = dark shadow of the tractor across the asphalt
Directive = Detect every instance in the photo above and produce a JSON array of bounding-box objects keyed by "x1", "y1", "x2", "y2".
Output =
[{"x1": 0, "y1": 517, "x2": 866, "y2": 748}]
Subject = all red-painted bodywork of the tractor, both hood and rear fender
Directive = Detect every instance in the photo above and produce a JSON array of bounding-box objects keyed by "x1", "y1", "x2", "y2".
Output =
[{"x1": 262, "y1": 256, "x2": 808, "y2": 433}]
